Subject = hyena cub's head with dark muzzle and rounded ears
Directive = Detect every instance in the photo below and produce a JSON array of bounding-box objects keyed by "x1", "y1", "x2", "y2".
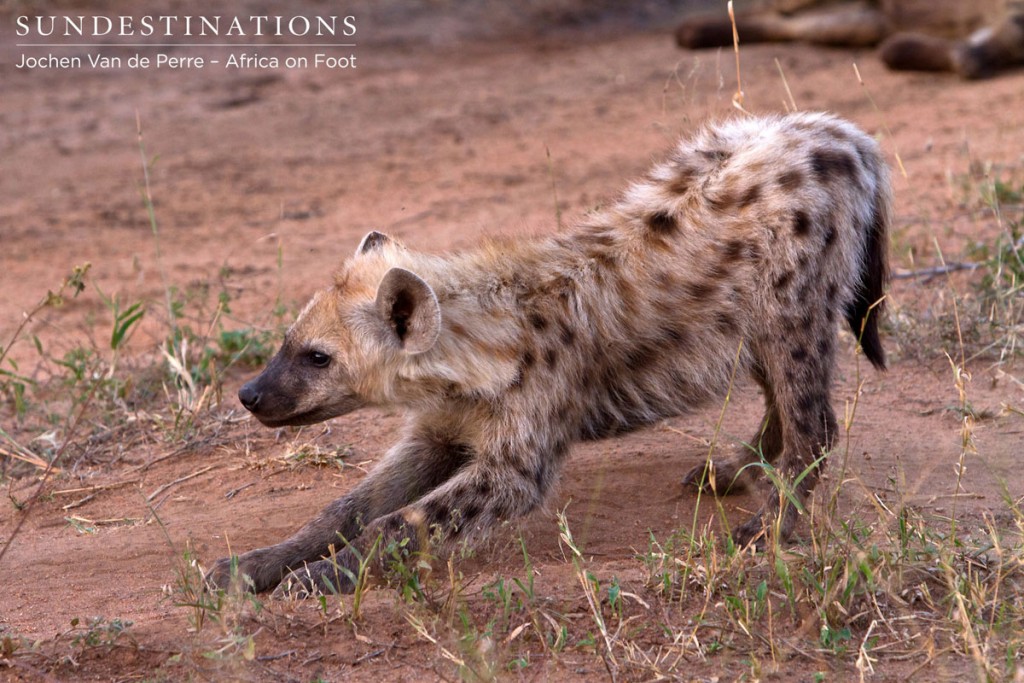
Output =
[{"x1": 239, "y1": 232, "x2": 441, "y2": 427}]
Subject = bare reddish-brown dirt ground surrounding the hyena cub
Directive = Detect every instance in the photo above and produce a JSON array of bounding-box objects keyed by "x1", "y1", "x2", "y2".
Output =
[{"x1": 0, "y1": 2, "x2": 1024, "y2": 680}]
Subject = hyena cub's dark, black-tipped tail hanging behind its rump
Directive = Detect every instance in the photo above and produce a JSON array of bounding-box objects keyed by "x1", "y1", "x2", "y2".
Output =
[{"x1": 846, "y1": 177, "x2": 893, "y2": 370}]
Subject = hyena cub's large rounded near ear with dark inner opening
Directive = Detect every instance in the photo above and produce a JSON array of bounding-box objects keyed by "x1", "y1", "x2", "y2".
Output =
[{"x1": 377, "y1": 268, "x2": 441, "y2": 354}]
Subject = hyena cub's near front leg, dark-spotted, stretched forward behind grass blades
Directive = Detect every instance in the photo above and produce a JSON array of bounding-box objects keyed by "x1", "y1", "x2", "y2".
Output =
[{"x1": 276, "y1": 440, "x2": 564, "y2": 597}]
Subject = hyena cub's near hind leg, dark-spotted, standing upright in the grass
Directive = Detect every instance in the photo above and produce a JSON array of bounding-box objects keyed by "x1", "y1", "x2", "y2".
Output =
[{"x1": 733, "y1": 327, "x2": 837, "y2": 547}]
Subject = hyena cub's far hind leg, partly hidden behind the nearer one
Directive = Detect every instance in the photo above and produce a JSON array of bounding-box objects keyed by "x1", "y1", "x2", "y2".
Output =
[{"x1": 683, "y1": 365, "x2": 782, "y2": 496}]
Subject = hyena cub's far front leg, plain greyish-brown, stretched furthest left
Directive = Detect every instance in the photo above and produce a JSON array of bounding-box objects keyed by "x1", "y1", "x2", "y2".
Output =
[{"x1": 207, "y1": 432, "x2": 473, "y2": 592}]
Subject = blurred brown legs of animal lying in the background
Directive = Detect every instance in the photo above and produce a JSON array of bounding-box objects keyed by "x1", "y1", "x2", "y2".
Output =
[{"x1": 676, "y1": 0, "x2": 1024, "y2": 79}]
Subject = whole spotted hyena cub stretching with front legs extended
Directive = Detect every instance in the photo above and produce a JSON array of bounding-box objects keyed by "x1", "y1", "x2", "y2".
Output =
[{"x1": 210, "y1": 109, "x2": 891, "y2": 595}]
